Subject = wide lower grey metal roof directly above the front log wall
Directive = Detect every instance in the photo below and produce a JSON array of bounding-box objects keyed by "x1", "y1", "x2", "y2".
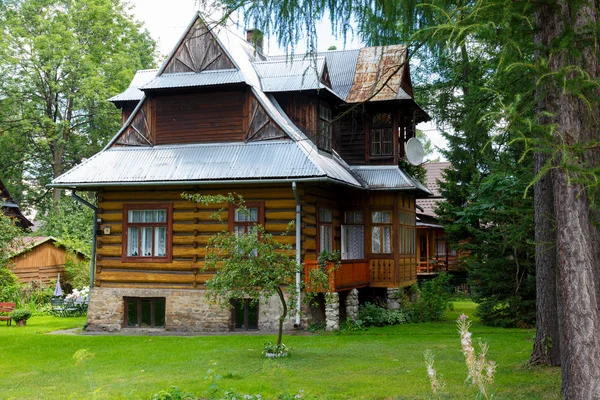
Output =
[{"x1": 50, "y1": 140, "x2": 361, "y2": 188}]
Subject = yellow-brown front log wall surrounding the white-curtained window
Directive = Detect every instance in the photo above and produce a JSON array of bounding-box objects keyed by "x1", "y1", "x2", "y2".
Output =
[{"x1": 96, "y1": 184, "x2": 302, "y2": 289}]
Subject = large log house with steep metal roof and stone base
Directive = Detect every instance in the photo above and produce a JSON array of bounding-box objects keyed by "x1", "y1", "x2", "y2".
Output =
[{"x1": 51, "y1": 11, "x2": 430, "y2": 331}]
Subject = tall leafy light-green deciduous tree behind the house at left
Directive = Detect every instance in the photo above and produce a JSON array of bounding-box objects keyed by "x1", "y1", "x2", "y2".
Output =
[{"x1": 0, "y1": 0, "x2": 155, "y2": 206}]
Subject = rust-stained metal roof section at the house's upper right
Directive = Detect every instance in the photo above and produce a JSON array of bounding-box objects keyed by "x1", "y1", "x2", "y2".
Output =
[{"x1": 346, "y1": 45, "x2": 412, "y2": 103}]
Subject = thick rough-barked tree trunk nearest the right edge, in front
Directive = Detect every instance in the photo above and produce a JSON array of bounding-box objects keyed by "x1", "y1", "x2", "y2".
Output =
[{"x1": 537, "y1": 0, "x2": 600, "y2": 400}]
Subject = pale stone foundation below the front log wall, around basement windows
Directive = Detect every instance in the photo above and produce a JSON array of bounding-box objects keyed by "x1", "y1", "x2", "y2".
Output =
[{"x1": 87, "y1": 287, "x2": 307, "y2": 332}]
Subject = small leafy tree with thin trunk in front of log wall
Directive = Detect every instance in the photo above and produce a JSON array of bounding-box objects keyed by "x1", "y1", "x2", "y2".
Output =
[{"x1": 182, "y1": 193, "x2": 300, "y2": 348}]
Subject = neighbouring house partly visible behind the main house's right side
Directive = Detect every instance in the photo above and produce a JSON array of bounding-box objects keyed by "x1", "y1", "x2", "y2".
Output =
[{"x1": 417, "y1": 162, "x2": 458, "y2": 276}]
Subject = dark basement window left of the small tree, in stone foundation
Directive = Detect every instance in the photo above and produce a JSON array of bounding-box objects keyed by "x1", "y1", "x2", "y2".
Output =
[{"x1": 123, "y1": 297, "x2": 166, "y2": 328}]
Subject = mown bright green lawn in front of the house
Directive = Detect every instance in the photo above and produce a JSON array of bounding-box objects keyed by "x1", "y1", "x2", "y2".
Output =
[{"x1": 0, "y1": 302, "x2": 561, "y2": 400}]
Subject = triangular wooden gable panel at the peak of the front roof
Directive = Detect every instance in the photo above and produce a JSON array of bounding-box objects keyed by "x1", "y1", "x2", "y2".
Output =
[{"x1": 162, "y1": 18, "x2": 235, "y2": 74}]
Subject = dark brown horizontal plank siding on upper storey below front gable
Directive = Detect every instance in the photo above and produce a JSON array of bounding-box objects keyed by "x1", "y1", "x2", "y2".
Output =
[{"x1": 155, "y1": 91, "x2": 247, "y2": 145}]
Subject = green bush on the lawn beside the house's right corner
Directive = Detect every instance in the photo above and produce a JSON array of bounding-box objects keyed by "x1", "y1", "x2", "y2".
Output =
[{"x1": 410, "y1": 273, "x2": 451, "y2": 322}]
